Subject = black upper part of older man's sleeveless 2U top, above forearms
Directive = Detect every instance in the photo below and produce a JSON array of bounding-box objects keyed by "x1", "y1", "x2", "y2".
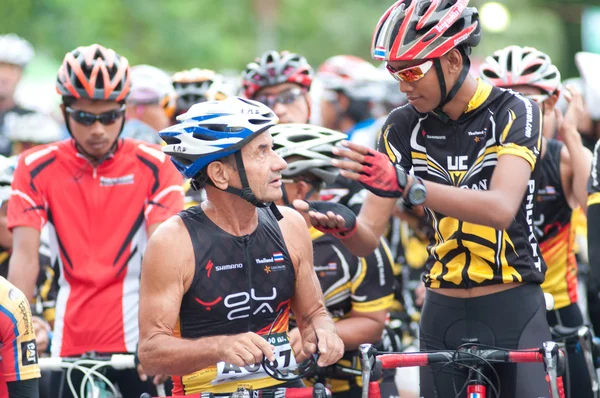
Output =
[{"x1": 179, "y1": 206, "x2": 295, "y2": 338}]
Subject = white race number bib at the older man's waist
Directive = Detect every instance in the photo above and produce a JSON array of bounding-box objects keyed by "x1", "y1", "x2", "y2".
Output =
[{"x1": 212, "y1": 333, "x2": 297, "y2": 385}]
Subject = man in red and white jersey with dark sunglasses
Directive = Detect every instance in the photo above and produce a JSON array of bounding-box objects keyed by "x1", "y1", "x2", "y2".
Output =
[{"x1": 8, "y1": 44, "x2": 183, "y2": 397}]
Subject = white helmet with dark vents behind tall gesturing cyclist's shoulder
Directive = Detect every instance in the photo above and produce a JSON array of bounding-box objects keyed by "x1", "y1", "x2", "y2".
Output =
[{"x1": 480, "y1": 46, "x2": 560, "y2": 95}]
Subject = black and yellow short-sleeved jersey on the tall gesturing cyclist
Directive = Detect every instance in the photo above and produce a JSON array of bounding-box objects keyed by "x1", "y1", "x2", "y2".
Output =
[{"x1": 379, "y1": 80, "x2": 546, "y2": 288}]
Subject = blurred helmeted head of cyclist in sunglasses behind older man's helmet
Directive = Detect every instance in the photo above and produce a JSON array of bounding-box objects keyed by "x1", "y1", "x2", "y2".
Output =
[{"x1": 242, "y1": 51, "x2": 314, "y2": 123}]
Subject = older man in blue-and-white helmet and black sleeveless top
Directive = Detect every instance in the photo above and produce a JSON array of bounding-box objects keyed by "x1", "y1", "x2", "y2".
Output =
[{"x1": 139, "y1": 97, "x2": 344, "y2": 394}]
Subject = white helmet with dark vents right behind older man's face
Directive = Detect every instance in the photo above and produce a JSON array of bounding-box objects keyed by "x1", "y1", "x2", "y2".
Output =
[{"x1": 269, "y1": 123, "x2": 348, "y2": 184}]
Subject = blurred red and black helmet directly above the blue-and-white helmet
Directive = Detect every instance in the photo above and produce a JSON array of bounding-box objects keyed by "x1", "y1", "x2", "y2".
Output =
[{"x1": 242, "y1": 51, "x2": 314, "y2": 99}]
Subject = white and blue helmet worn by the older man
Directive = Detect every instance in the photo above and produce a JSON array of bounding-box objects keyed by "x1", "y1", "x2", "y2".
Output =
[{"x1": 159, "y1": 97, "x2": 279, "y2": 178}]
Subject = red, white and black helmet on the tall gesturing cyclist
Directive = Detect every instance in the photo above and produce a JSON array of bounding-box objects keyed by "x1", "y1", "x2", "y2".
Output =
[{"x1": 371, "y1": 0, "x2": 481, "y2": 61}]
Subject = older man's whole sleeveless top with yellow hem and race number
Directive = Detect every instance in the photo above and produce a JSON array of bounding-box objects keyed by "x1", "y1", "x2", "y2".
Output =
[{"x1": 173, "y1": 206, "x2": 296, "y2": 394}]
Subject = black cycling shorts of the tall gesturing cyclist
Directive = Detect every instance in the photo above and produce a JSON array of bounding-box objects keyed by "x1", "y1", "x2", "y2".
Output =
[{"x1": 420, "y1": 284, "x2": 551, "y2": 398}]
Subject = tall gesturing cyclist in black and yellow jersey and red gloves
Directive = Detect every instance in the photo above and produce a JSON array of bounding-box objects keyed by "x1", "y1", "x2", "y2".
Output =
[{"x1": 296, "y1": 0, "x2": 550, "y2": 398}]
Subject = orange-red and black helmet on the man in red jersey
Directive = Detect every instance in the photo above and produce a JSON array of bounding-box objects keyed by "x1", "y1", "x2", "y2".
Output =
[{"x1": 56, "y1": 44, "x2": 131, "y2": 102}]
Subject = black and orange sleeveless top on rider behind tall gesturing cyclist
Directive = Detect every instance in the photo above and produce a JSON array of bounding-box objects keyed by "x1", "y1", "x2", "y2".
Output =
[{"x1": 535, "y1": 140, "x2": 577, "y2": 310}]
